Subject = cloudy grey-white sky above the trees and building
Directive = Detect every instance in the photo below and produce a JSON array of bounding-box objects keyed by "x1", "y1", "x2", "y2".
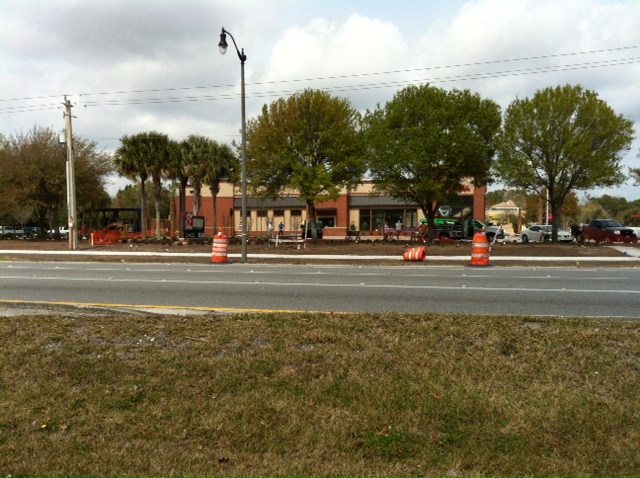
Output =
[{"x1": 0, "y1": 0, "x2": 640, "y2": 201}]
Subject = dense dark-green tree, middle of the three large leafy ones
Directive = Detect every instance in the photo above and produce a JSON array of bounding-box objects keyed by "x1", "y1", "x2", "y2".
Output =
[{"x1": 366, "y1": 85, "x2": 500, "y2": 242}]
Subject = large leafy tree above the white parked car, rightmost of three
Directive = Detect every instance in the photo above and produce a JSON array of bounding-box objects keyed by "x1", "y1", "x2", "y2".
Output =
[{"x1": 495, "y1": 85, "x2": 634, "y2": 241}]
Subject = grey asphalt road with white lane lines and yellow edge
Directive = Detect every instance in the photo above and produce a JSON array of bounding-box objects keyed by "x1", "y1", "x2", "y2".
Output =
[{"x1": 0, "y1": 262, "x2": 640, "y2": 318}]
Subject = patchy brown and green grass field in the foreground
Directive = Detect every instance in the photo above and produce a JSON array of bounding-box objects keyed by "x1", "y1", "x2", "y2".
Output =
[{"x1": 0, "y1": 313, "x2": 640, "y2": 478}]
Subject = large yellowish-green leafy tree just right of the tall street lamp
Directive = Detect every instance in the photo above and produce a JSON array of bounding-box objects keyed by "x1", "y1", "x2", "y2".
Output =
[{"x1": 247, "y1": 89, "x2": 366, "y2": 240}]
